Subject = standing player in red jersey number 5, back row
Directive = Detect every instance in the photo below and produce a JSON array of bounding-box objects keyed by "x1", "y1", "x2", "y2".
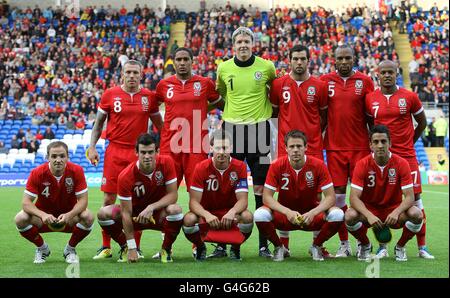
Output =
[{"x1": 320, "y1": 45, "x2": 374, "y2": 258}]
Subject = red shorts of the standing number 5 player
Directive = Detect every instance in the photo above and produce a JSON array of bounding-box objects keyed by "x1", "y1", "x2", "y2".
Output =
[{"x1": 327, "y1": 150, "x2": 370, "y2": 186}]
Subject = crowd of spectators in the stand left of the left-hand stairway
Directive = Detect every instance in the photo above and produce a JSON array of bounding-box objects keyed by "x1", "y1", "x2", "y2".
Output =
[{"x1": 0, "y1": 4, "x2": 180, "y2": 124}]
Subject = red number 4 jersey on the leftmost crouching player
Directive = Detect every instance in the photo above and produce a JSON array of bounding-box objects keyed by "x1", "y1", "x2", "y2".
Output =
[{"x1": 25, "y1": 161, "x2": 88, "y2": 217}]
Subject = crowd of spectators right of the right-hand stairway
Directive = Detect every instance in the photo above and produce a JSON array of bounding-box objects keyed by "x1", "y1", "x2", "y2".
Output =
[{"x1": 398, "y1": 1, "x2": 449, "y2": 114}]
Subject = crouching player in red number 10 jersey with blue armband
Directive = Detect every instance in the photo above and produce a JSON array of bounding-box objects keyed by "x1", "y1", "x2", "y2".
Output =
[{"x1": 183, "y1": 130, "x2": 253, "y2": 261}]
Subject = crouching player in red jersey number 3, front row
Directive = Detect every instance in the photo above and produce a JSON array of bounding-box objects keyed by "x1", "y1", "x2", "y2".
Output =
[{"x1": 345, "y1": 125, "x2": 423, "y2": 261}]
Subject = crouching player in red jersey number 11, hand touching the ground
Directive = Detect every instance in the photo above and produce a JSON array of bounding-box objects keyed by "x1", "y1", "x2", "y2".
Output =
[{"x1": 97, "y1": 133, "x2": 183, "y2": 263}]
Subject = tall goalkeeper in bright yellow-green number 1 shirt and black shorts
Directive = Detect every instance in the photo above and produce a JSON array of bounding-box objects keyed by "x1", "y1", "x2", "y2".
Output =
[{"x1": 213, "y1": 27, "x2": 276, "y2": 257}]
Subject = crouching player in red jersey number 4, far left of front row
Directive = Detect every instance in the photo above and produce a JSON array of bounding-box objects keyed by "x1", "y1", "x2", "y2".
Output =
[{"x1": 15, "y1": 141, "x2": 94, "y2": 264}]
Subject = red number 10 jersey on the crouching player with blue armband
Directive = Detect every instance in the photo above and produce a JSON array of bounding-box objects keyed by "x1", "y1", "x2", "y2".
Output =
[{"x1": 191, "y1": 158, "x2": 248, "y2": 211}]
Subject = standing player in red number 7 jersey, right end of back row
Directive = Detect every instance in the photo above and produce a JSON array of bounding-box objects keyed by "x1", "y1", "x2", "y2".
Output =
[{"x1": 366, "y1": 60, "x2": 434, "y2": 259}]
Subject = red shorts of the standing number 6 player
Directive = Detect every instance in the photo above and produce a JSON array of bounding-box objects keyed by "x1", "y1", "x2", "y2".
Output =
[{"x1": 161, "y1": 152, "x2": 208, "y2": 191}]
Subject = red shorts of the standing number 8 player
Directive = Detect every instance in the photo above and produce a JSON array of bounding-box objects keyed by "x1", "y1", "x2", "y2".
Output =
[{"x1": 100, "y1": 143, "x2": 137, "y2": 194}]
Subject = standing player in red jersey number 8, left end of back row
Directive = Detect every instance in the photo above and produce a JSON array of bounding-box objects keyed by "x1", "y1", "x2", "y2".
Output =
[{"x1": 87, "y1": 60, "x2": 162, "y2": 259}]
